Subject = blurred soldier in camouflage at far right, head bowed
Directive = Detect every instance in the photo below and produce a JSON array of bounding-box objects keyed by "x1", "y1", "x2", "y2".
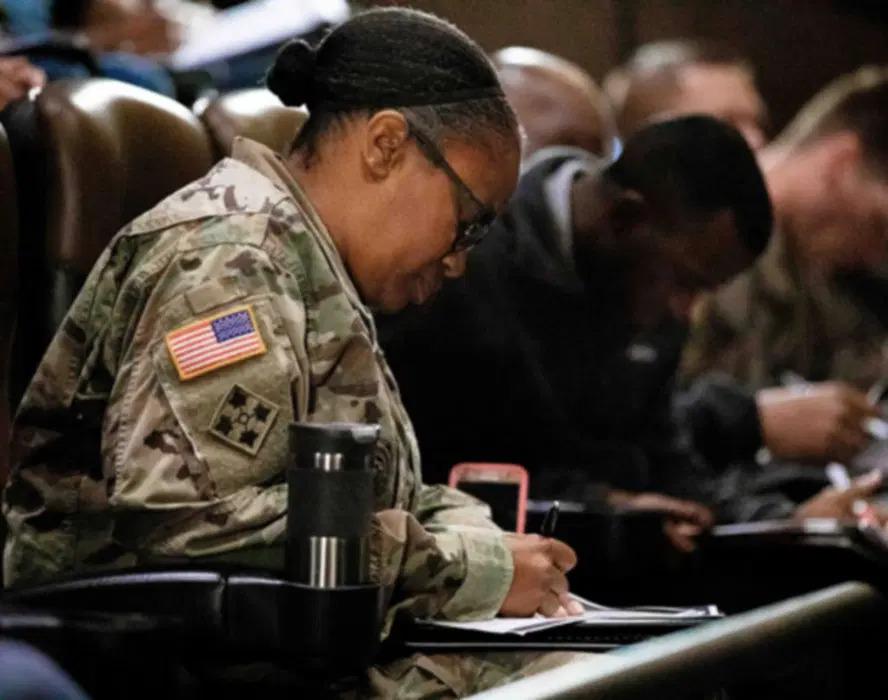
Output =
[{"x1": 684, "y1": 67, "x2": 888, "y2": 468}]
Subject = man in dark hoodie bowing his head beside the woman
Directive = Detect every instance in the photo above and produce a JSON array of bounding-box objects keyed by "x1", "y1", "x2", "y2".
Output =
[{"x1": 381, "y1": 110, "x2": 878, "y2": 536}]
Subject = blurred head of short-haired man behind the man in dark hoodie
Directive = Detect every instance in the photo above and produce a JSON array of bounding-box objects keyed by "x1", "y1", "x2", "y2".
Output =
[{"x1": 604, "y1": 39, "x2": 768, "y2": 149}]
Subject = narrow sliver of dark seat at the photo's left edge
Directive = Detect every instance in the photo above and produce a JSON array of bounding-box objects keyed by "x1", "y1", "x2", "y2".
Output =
[{"x1": 0, "y1": 126, "x2": 18, "y2": 488}]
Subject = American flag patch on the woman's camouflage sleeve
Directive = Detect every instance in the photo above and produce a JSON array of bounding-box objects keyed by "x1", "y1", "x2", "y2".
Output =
[{"x1": 165, "y1": 306, "x2": 266, "y2": 382}]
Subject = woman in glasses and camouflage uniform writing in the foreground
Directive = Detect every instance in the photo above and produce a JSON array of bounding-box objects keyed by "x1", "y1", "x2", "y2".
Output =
[{"x1": 4, "y1": 9, "x2": 596, "y2": 696}]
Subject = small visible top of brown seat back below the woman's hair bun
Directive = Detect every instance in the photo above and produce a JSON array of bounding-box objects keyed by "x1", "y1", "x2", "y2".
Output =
[{"x1": 196, "y1": 88, "x2": 308, "y2": 158}]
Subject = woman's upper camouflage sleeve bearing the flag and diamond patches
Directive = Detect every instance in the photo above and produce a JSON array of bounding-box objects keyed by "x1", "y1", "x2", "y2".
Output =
[{"x1": 103, "y1": 244, "x2": 307, "y2": 557}]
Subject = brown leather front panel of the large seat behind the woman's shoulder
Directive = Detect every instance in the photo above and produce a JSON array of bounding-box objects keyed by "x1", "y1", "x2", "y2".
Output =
[{"x1": 43, "y1": 80, "x2": 212, "y2": 288}]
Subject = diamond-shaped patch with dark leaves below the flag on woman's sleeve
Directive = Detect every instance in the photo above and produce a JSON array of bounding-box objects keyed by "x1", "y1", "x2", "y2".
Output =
[{"x1": 209, "y1": 384, "x2": 280, "y2": 455}]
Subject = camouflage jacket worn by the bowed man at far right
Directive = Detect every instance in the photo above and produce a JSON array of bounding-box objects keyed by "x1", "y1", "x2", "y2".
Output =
[{"x1": 683, "y1": 233, "x2": 888, "y2": 390}]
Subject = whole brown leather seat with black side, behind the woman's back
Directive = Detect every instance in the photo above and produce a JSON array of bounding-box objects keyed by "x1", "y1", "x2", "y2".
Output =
[{"x1": 3, "y1": 79, "x2": 213, "y2": 398}]
